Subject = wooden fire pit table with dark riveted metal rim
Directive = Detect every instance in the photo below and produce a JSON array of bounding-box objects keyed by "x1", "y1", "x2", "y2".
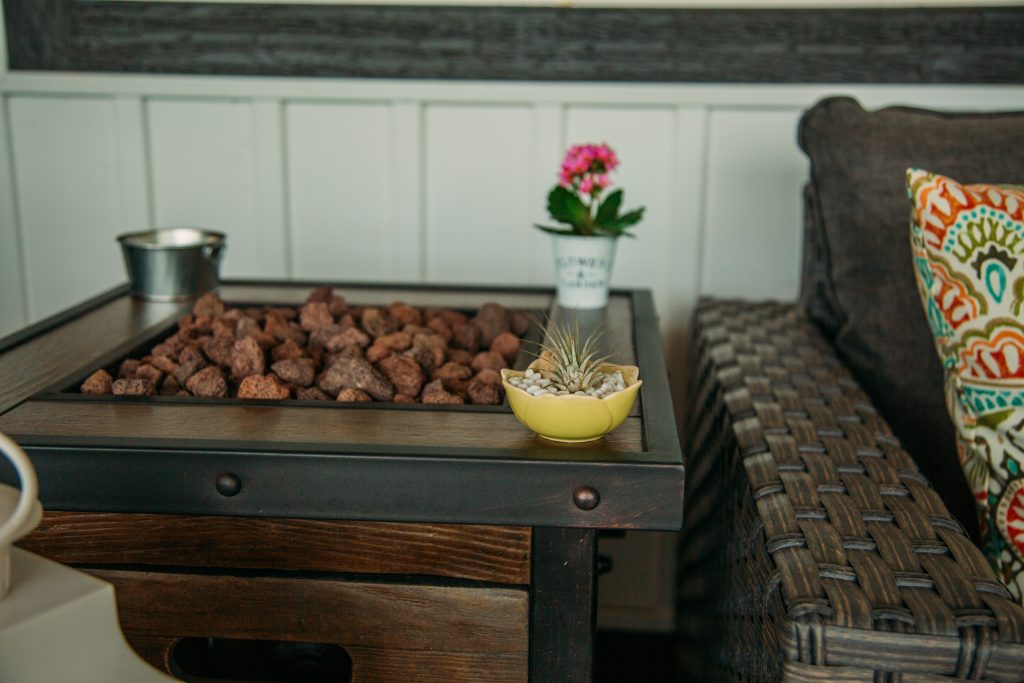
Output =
[{"x1": 0, "y1": 281, "x2": 683, "y2": 682}]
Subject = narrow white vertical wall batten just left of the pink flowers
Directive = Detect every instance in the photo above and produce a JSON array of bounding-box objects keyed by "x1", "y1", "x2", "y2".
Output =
[{"x1": 524, "y1": 103, "x2": 566, "y2": 286}]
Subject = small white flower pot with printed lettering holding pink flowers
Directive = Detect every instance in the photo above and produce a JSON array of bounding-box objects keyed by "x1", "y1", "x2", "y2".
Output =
[{"x1": 551, "y1": 234, "x2": 616, "y2": 308}]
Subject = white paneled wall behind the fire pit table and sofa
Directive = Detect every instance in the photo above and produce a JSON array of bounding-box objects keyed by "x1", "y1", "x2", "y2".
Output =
[{"x1": 0, "y1": 73, "x2": 1024, "y2": 348}]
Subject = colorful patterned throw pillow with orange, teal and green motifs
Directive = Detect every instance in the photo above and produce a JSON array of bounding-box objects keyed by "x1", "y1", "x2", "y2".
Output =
[{"x1": 906, "y1": 169, "x2": 1024, "y2": 602}]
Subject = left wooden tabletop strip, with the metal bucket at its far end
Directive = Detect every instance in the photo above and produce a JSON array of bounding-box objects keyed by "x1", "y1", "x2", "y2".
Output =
[{"x1": 0, "y1": 295, "x2": 187, "y2": 413}]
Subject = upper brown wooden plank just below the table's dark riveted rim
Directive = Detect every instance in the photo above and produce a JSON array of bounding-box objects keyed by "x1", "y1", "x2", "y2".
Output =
[{"x1": 18, "y1": 512, "x2": 530, "y2": 585}]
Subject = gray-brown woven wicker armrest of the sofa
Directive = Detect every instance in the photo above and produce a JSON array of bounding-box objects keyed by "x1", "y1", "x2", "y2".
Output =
[{"x1": 679, "y1": 301, "x2": 1024, "y2": 682}]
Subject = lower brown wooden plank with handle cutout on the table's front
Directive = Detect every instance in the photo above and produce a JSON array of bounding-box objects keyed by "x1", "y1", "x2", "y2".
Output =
[{"x1": 90, "y1": 569, "x2": 529, "y2": 681}]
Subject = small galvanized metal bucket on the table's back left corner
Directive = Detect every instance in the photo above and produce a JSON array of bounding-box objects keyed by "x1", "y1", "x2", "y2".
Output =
[{"x1": 118, "y1": 227, "x2": 225, "y2": 301}]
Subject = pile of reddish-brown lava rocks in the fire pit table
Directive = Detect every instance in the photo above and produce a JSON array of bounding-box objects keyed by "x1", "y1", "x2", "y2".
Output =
[{"x1": 81, "y1": 287, "x2": 529, "y2": 404}]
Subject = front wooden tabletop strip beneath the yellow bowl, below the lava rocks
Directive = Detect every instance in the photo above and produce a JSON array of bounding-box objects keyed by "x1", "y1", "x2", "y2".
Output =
[{"x1": 0, "y1": 399, "x2": 644, "y2": 460}]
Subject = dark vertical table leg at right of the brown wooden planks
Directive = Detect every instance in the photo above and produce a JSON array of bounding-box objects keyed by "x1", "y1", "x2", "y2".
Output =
[{"x1": 529, "y1": 527, "x2": 597, "y2": 683}]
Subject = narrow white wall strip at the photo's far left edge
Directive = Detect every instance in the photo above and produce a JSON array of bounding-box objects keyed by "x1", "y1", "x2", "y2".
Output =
[{"x1": 0, "y1": 98, "x2": 28, "y2": 337}]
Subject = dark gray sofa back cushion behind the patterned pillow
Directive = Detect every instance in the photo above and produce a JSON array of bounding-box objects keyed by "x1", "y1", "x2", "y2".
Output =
[{"x1": 799, "y1": 97, "x2": 1024, "y2": 539}]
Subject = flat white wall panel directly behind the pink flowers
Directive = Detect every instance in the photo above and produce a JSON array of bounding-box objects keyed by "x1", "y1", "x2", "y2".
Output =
[{"x1": 566, "y1": 106, "x2": 677, "y2": 331}]
